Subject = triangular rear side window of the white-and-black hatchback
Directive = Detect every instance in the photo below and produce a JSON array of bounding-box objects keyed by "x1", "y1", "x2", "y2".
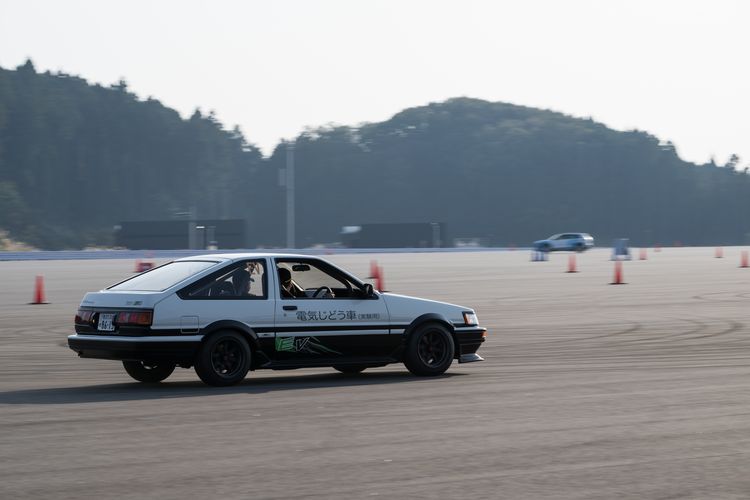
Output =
[{"x1": 178, "y1": 259, "x2": 268, "y2": 300}]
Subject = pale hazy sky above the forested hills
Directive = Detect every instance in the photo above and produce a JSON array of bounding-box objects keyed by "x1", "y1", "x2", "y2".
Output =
[{"x1": 0, "y1": 0, "x2": 750, "y2": 166}]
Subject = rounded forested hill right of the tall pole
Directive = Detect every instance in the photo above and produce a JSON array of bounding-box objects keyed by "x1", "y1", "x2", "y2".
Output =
[{"x1": 270, "y1": 98, "x2": 750, "y2": 245}]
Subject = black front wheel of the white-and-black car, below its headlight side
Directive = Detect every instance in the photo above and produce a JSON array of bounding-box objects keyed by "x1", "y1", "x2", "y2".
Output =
[{"x1": 404, "y1": 323, "x2": 455, "y2": 376}]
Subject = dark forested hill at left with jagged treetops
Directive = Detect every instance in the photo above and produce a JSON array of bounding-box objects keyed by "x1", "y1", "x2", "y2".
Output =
[{"x1": 0, "y1": 63, "x2": 262, "y2": 248}]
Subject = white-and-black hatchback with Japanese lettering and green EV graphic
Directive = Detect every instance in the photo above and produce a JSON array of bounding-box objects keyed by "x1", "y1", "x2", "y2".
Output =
[{"x1": 68, "y1": 254, "x2": 486, "y2": 386}]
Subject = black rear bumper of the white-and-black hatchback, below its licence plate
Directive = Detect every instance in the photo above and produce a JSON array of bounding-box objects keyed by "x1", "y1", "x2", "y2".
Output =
[{"x1": 68, "y1": 335, "x2": 203, "y2": 364}]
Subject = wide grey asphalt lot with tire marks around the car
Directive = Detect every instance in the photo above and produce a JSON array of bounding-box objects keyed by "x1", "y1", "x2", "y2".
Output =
[{"x1": 0, "y1": 248, "x2": 750, "y2": 499}]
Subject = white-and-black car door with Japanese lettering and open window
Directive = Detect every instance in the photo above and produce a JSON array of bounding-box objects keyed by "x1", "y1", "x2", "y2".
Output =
[{"x1": 274, "y1": 258, "x2": 398, "y2": 362}]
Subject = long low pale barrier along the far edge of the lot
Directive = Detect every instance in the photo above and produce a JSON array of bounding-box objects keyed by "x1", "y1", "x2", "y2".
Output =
[{"x1": 0, "y1": 247, "x2": 516, "y2": 261}]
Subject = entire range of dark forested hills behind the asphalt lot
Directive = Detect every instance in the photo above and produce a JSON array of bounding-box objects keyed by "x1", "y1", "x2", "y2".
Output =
[{"x1": 0, "y1": 63, "x2": 750, "y2": 248}]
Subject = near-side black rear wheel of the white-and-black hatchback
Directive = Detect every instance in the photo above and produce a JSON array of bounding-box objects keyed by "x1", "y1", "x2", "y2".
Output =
[{"x1": 195, "y1": 330, "x2": 251, "y2": 386}]
